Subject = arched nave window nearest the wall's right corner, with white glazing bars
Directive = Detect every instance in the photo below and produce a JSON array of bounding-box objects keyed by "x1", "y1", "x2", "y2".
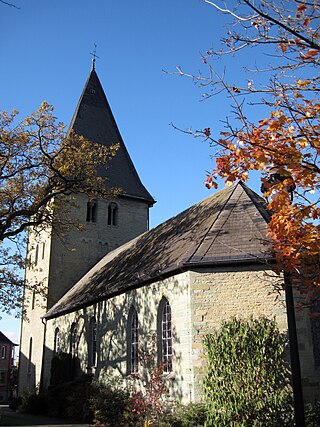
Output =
[{"x1": 158, "y1": 298, "x2": 173, "y2": 373}]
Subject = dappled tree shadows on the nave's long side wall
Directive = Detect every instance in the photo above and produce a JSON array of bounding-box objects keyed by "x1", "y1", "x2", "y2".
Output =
[{"x1": 41, "y1": 282, "x2": 183, "y2": 399}]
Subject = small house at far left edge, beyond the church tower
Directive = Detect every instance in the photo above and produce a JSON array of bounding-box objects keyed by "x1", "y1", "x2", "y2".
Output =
[{"x1": 0, "y1": 331, "x2": 17, "y2": 404}]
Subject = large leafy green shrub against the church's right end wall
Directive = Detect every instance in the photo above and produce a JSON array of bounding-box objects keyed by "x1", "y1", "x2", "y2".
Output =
[{"x1": 204, "y1": 318, "x2": 293, "y2": 427}]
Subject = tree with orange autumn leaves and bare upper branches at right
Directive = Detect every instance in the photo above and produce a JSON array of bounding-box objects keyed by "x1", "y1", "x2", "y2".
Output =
[{"x1": 177, "y1": 0, "x2": 320, "y2": 294}]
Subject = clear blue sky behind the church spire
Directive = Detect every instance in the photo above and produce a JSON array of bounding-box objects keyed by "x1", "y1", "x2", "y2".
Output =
[{"x1": 0, "y1": 0, "x2": 268, "y2": 339}]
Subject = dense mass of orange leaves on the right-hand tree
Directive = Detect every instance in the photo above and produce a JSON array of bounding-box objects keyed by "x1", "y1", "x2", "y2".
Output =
[{"x1": 206, "y1": 88, "x2": 320, "y2": 286}]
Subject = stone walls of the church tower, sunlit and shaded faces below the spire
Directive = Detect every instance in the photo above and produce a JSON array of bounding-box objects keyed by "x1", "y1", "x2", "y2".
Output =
[{"x1": 19, "y1": 194, "x2": 149, "y2": 393}]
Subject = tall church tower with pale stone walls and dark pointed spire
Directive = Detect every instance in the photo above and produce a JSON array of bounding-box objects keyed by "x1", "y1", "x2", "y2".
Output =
[{"x1": 19, "y1": 61, "x2": 155, "y2": 393}]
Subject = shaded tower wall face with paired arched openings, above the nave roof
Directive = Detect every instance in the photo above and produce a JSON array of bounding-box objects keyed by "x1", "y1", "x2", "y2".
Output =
[{"x1": 48, "y1": 195, "x2": 149, "y2": 308}]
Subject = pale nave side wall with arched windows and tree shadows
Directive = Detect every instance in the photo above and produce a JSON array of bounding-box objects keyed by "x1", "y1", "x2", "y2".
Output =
[{"x1": 46, "y1": 273, "x2": 193, "y2": 403}]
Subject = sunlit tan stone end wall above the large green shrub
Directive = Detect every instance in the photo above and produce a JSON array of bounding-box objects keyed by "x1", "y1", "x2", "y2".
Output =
[{"x1": 190, "y1": 265, "x2": 287, "y2": 400}]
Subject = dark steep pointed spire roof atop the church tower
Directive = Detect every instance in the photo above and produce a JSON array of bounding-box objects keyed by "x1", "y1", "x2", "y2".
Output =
[{"x1": 70, "y1": 66, "x2": 155, "y2": 205}]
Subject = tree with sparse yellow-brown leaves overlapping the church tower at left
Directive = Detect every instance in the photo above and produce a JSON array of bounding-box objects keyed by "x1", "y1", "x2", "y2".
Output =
[{"x1": 0, "y1": 102, "x2": 117, "y2": 312}]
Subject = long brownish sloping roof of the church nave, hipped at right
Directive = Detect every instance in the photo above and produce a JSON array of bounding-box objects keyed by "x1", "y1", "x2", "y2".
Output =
[{"x1": 45, "y1": 182, "x2": 272, "y2": 318}]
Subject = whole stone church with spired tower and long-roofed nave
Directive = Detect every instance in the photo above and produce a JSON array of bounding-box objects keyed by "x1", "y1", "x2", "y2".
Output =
[{"x1": 19, "y1": 62, "x2": 320, "y2": 403}]
